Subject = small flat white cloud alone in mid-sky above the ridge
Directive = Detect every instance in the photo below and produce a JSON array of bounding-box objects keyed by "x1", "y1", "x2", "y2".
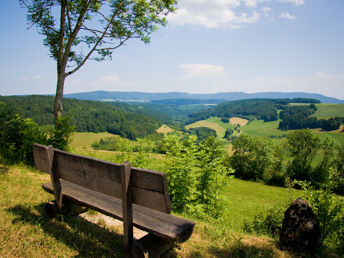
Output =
[{"x1": 179, "y1": 64, "x2": 225, "y2": 78}]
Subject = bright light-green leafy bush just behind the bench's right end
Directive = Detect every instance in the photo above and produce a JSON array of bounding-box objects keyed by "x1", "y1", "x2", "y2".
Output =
[{"x1": 162, "y1": 135, "x2": 228, "y2": 217}]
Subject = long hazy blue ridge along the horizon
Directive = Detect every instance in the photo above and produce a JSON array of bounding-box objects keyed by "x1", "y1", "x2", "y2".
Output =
[{"x1": 65, "y1": 91, "x2": 344, "y2": 104}]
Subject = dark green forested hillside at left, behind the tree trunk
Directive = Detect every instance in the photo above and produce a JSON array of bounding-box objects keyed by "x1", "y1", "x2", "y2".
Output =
[{"x1": 0, "y1": 96, "x2": 161, "y2": 139}]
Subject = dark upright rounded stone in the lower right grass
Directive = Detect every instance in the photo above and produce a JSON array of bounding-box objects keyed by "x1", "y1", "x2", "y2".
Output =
[{"x1": 280, "y1": 198, "x2": 320, "y2": 252}]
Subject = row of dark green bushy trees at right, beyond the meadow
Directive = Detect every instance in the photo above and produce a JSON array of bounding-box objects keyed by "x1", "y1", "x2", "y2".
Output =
[{"x1": 230, "y1": 129, "x2": 344, "y2": 194}]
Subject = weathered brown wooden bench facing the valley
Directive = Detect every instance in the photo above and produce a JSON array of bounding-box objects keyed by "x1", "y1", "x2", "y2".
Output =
[{"x1": 33, "y1": 144, "x2": 195, "y2": 257}]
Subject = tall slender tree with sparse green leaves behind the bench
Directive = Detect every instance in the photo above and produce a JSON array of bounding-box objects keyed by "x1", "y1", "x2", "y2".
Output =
[{"x1": 19, "y1": 0, "x2": 176, "y2": 119}]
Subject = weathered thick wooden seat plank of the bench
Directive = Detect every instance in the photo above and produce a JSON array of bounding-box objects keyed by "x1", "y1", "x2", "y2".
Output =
[{"x1": 43, "y1": 180, "x2": 195, "y2": 243}]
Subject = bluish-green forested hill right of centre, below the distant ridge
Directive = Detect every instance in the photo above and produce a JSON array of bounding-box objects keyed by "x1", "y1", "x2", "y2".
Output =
[{"x1": 188, "y1": 98, "x2": 320, "y2": 123}]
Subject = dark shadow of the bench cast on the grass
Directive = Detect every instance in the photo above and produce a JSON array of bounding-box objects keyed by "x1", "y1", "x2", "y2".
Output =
[{"x1": 6, "y1": 203, "x2": 126, "y2": 257}]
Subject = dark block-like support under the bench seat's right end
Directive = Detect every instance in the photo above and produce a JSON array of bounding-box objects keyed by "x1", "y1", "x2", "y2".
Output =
[{"x1": 131, "y1": 234, "x2": 175, "y2": 258}]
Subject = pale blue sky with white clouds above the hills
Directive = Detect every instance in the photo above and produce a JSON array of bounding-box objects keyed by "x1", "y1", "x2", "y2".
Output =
[{"x1": 0, "y1": 0, "x2": 344, "y2": 99}]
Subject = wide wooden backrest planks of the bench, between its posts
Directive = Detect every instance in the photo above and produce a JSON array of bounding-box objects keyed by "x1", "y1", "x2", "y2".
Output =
[{"x1": 33, "y1": 144, "x2": 171, "y2": 213}]
